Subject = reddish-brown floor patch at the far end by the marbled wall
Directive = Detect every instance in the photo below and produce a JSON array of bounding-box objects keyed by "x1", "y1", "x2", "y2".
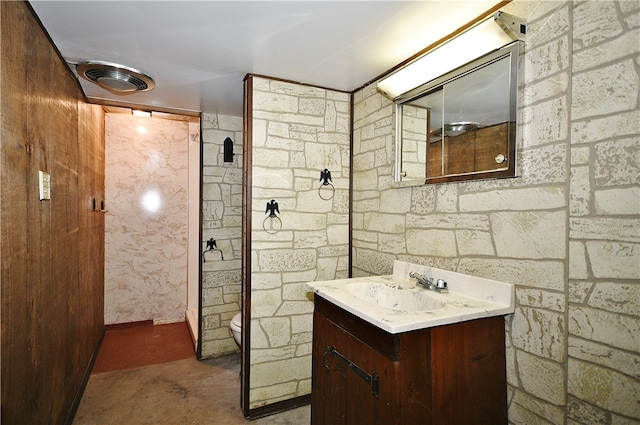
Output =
[{"x1": 91, "y1": 321, "x2": 195, "y2": 374}]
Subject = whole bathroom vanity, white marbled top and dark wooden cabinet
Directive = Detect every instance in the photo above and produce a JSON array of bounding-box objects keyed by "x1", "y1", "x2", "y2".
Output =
[{"x1": 307, "y1": 262, "x2": 514, "y2": 425}]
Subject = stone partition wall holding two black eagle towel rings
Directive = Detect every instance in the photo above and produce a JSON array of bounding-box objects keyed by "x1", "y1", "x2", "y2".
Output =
[{"x1": 246, "y1": 77, "x2": 350, "y2": 409}]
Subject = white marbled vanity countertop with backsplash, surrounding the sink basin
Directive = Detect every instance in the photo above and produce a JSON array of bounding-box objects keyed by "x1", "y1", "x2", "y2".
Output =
[{"x1": 307, "y1": 261, "x2": 515, "y2": 334}]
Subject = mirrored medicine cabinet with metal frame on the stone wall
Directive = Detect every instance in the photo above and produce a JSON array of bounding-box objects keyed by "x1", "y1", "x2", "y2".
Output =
[{"x1": 394, "y1": 42, "x2": 519, "y2": 186}]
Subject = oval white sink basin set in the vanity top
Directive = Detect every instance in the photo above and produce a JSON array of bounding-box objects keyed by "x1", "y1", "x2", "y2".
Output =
[{"x1": 347, "y1": 282, "x2": 445, "y2": 312}]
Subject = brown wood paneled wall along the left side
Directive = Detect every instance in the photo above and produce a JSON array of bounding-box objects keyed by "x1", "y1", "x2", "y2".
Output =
[{"x1": 0, "y1": 2, "x2": 104, "y2": 424}]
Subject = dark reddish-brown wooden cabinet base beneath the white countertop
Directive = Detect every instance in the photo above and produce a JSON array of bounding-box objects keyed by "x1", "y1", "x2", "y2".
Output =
[{"x1": 311, "y1": 295, "x2": 507, "y2": 425}]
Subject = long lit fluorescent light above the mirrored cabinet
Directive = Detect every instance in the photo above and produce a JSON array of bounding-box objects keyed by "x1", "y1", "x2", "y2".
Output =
[{"x1": 378, "y1": 12, "x2": 524, "y2": 99}]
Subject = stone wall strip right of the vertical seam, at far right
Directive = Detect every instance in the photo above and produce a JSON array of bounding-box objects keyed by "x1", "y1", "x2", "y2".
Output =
[{"x1": 559, "y1": 0, "x2": 640, "y2": 424}]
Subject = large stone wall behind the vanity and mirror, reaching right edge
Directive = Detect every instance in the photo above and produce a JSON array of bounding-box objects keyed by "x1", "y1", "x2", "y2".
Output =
[{"x1": 352, "y1": 0, "x2": 640, "y2": 425}]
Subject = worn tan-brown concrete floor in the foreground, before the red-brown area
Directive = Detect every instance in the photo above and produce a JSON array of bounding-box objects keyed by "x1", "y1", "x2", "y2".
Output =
[{"x1": 73, "y1": 354, "x2": 311, "y2": 425}]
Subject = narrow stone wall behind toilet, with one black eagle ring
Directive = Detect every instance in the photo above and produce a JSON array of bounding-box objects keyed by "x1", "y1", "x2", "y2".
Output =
[{"x1": 200, "y1": 113, "x2": 242, "y2": 358}]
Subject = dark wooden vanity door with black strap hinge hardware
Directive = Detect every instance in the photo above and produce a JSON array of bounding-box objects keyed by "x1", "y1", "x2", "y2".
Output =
[{"x1": 311, "y1": 302, "x2": 401, "y2": 425}]
